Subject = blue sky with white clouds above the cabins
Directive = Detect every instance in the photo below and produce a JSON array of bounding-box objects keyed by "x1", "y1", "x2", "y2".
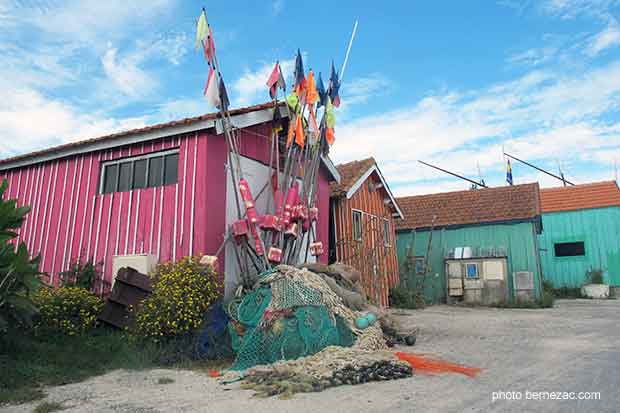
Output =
[{"x1": 0, "y1": 0, "x2": 620, "y2": 195}]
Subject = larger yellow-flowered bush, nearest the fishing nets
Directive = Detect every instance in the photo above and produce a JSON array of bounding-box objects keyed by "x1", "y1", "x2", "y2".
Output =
[{"x1": 135, "y1": 257, "x2": 221, "y2": 341}]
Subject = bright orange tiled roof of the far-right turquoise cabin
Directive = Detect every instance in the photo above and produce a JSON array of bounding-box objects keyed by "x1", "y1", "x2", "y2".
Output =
[{"x1": 540, "y1": 181, "x2": 620, "y2": 212}]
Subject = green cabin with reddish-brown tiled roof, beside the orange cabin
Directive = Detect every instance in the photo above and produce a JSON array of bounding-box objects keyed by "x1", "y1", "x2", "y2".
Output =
[{"x1": 396, "y1": 184, "x2": 542, "y2": 304}]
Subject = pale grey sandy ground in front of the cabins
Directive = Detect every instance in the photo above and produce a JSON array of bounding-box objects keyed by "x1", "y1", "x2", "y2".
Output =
[{"x1": 0, "y1": 300, "x2": 620, "y2": 413}]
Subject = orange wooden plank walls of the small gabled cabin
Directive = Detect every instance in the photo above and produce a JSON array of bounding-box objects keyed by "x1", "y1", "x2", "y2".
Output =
[{"x1": 333, "y1": 176, "x2": 398, "y2": 307}]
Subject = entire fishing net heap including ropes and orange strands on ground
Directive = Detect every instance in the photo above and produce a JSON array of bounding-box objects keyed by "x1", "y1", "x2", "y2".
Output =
[{"x1": 214, "y1": 264, "x2": 480, "y2": 398}]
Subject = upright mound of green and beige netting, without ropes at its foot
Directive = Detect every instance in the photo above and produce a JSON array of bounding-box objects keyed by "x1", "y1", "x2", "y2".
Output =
[{"x1": 227, "y1": 265, "x2": 368, "y2": 371}]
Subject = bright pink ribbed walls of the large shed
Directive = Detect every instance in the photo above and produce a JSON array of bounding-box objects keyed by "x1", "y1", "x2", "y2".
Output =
[{"x1": 0, "y1": 124, "x2": 329, "y2": 284}]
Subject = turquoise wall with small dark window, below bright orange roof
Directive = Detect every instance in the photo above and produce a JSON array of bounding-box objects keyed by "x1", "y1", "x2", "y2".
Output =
[{"x1": 539, "y1": 207, "x2": 620, "y2": 288}]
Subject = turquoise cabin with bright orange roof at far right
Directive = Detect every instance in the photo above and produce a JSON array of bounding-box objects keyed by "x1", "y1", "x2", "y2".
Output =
[{"x1": 539, "y1": 181, "x2": 620, "y2": 288}]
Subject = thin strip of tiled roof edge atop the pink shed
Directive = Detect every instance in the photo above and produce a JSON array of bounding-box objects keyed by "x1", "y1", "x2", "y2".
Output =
[{"x1": 0, "y1": 102, "x2": 273, "y2": 165}]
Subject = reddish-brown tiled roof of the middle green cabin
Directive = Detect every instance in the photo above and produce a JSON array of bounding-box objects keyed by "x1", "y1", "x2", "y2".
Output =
[{"x1": 396, "y1": 183, "x2": 540, "y2": 230}]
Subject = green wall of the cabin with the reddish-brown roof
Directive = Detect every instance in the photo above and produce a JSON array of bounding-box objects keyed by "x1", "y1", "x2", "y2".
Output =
[{"x1": 396, "y1": 222, "x2": 540, "y2": 304}]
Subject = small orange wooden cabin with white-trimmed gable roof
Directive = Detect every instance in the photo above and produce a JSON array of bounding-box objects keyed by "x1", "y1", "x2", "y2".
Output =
[{"x1": 329, "y1": 158, "x2": 403, "y2": 307}]
